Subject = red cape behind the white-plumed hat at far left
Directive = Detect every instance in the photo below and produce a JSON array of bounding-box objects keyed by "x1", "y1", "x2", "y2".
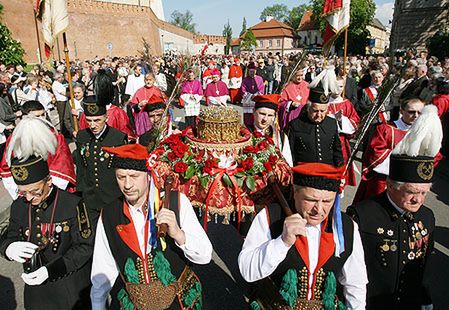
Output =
[{"x1": 0, "y1": 130, "x2": 76, "y2": 192}]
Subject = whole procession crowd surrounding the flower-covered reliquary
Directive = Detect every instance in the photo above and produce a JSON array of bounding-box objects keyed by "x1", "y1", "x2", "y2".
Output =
[{"x1": 0, "y1": 49, "x2": 449, "y2": 309}]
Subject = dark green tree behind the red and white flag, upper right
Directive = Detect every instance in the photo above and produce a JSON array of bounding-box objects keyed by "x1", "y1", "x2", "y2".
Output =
[{"x1": 311, "y1": 0, "x2": 376, "y2": 55}]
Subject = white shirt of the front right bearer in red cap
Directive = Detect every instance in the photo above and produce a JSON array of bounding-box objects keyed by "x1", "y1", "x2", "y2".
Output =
[{"x1": 238, "y1": 210, "x2": 368, "y2": 309}]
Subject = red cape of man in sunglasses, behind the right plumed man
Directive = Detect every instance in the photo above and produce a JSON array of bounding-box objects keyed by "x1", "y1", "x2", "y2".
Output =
[{"x1": 353, "y1": 122, "x2": 407, "y2": 203}]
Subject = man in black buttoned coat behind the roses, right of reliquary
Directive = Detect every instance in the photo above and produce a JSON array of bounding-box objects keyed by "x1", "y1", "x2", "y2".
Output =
[{"x1": 288, "y1": 86, "x2": 343, "y2": 166}]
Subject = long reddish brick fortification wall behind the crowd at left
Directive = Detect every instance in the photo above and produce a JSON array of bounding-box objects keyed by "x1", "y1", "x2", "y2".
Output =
[{"x1": 2, "y1": 0, "x2": 186, "y2": 63}]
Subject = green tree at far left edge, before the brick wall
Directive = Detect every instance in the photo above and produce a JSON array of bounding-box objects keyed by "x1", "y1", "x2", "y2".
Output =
[{"x1": 0, "y1": 4, "x2": 25, "y2": 65}]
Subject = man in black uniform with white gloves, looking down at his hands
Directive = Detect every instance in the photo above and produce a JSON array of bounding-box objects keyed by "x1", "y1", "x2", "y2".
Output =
[{"x1": 0, "y1": 124, "x2": 94, "y2": 310}]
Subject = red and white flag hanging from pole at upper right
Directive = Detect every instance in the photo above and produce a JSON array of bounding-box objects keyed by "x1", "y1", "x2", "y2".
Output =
[{"x1": 323, "y1": 0, "x2": 351, "y2": 54}]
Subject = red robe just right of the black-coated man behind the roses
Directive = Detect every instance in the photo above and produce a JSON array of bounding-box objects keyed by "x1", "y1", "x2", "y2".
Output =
[{"x1": 328, "y1": 99, "x2": 360, "y2": 186}]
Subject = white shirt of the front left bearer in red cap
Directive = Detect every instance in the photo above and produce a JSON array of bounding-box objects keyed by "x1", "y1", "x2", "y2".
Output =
[{"x1": 90, "y1": 193, "x2": 212, "y2": 310}]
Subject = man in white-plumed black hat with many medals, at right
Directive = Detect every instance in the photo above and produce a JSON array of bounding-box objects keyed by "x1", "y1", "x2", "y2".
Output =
[{"x1": 347, "y1": 107, "x2": 441, "y2": 310}]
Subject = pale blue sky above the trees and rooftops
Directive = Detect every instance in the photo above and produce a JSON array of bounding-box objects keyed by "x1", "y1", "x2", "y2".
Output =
[{"x1": 162, "y1": 0, "x2": 394, "y2": 37}]
